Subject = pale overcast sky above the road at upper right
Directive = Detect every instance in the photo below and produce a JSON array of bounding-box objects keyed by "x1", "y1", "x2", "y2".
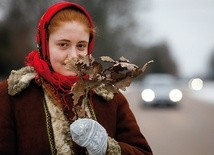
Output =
[{"x1": 136, "y1": 0, "x2": 214, "y2": 77}]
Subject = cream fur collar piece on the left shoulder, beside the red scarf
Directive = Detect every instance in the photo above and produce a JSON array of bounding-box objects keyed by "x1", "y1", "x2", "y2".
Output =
[{"x1": 7, "y1": 66, "x2": 36, "y2": 96}]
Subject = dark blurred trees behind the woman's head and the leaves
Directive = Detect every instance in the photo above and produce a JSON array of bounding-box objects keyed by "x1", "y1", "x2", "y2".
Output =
[{"x1": 0, "y1": 0, "x2": 178, "y2": 77}]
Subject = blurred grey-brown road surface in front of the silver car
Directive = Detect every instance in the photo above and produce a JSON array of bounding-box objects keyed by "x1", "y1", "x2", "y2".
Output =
[{"x1": 124, "y1": 86, "x2": 214, "y2": 155}]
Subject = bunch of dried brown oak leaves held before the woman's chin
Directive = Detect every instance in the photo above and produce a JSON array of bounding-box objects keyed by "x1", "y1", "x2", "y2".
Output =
[{"x1": 65, "y1": 55, "x2": 153, "y2": 105}]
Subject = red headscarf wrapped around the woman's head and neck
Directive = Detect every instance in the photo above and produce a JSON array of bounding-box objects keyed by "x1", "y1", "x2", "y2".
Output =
[{"x1": 26, "y1": 2, "x2": 94, "y2": 106}]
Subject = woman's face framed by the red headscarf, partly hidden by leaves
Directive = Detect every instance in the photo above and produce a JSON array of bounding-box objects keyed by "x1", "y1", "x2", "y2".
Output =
[{"x1": 49, "y1": 22, "x2": 89, "y2": 76}]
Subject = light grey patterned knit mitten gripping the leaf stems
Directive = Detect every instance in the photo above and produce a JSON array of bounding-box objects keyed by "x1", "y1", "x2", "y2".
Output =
[{"x1": 70, "y1": 118, "x2": 108, "y2": 155}]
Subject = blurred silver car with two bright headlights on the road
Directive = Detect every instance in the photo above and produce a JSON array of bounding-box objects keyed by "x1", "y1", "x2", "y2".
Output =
[{"x1": 141, "y1": 73, "x2": 183, "y2": 106}]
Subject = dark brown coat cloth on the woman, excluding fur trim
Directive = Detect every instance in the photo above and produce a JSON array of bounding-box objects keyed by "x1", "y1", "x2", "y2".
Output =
[{"x1": 0, "y1": 81, "x2": 152, "y2": 155}]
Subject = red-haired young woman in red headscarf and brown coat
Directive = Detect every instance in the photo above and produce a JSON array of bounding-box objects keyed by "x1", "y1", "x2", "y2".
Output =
[{"x1": 0, "y1": 2, "x2": 152, "y2": 155}]
